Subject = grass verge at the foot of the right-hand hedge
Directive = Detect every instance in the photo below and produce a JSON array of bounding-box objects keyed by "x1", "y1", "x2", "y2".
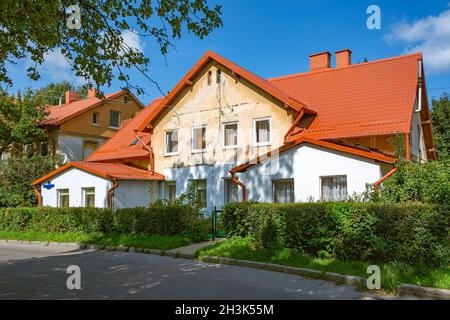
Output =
[{"x1": 197, "y1": 237, "x2": 450, "y2": 292}]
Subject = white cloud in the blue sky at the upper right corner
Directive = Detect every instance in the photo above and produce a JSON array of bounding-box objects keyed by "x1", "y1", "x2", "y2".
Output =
[{"x1": 385, "y1": 3, "x2": 450, "y2": 73}]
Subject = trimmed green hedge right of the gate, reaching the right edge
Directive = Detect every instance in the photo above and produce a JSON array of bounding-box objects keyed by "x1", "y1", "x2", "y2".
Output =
[{"x1": 221, "y1": 202, "x2": 450, "y2": 266}]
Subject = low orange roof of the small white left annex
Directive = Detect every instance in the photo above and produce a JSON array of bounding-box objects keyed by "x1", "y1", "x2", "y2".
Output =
[{"x1": 33, "y1": 162, "x2": 165, "y2": 185}]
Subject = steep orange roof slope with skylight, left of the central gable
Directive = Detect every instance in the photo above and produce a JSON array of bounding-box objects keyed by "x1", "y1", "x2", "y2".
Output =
[{"x1": 87, "y1": 98, "x2": 162, "y2": 161}]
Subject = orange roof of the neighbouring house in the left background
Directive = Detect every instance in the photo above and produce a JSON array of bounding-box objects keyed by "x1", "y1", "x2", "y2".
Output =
[{"x1": 40, "y1": 89, "x2": 144, "y2": 125}]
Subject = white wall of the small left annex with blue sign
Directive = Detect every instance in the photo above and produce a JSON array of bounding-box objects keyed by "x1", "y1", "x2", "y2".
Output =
[{"x1": 41, "y1": 168, "x2": 111, "y2": 208}]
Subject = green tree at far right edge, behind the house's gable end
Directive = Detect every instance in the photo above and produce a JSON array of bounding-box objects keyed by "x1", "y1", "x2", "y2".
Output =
[{"x1": 431, "y1": 93, "x2": 450, "y2": 159}]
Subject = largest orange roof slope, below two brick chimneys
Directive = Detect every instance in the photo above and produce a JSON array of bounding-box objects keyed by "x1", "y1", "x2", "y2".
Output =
[{"x1": 269, "y1": 53, "x2": 422, "y2": 139}]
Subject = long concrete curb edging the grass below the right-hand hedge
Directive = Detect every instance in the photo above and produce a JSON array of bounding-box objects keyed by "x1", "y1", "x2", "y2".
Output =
[{"x1": 201, "y1": 256, "x2": 366, "y2": 286}]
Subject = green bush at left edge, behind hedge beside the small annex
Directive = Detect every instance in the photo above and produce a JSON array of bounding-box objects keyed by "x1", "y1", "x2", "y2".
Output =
[{"x1": 0, "y1": 156, "x2": 60, "y2": 207}]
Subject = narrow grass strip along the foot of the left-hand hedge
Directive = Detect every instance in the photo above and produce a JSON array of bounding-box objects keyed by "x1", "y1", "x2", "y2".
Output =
[{"x1": 0, "y1": 231, "x2": 191, "y2": 250}]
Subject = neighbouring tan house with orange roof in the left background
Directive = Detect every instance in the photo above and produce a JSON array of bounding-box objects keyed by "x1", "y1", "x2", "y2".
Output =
[{"x1": 38, "y1": 89, "x2": 144, "y2": 163}]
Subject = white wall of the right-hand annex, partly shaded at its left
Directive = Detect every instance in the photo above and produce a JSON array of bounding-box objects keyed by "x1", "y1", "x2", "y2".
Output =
[{"x1": 238, "y1": 144, "x2": 387, "y2": 202}]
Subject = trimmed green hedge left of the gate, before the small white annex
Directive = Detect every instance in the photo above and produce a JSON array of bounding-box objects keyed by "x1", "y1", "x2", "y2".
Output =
[{"x1": 0, "y1": 203, "x2": 210, "y2": 241}]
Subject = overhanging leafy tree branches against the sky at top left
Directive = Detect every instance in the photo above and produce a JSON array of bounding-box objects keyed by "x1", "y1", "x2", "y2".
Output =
[{"x1": 0, "y1": 0, "x2": 222, "y2": 94}]
